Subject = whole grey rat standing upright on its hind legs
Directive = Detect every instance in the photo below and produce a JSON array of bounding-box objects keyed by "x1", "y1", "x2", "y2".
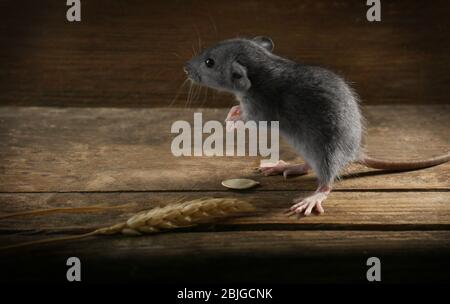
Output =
[{"x1": 184, "y1": 36, "x2": 450, "y2": 215}]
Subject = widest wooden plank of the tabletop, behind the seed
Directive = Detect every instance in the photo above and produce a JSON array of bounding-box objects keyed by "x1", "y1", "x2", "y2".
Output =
[{"x1": 0, "y1": 105, "x2": 450, "y2": 192}]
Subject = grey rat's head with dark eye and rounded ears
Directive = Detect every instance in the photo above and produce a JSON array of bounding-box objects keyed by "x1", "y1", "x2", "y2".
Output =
[{"x1": 184, "y1": 37, "x2": 273, "y2": 93}]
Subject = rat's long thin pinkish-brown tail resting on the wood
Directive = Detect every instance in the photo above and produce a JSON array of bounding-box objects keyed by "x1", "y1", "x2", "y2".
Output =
[{"x1": 356, "y1": 152, "x2": 450, "y2": 171}]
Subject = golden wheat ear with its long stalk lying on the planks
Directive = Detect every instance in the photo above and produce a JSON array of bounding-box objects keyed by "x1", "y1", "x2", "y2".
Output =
[{"x1": 0, "y1": 198, "x2": 254, "y2": 250}]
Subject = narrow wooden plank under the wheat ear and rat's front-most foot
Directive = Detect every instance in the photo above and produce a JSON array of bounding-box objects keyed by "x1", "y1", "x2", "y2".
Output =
[{"x1": 0, "y1": 191, "x2": 450, "y2": 234}]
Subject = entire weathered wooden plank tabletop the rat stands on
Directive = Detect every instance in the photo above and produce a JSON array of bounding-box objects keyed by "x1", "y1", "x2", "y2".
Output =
[{"x1": 0, "y1": 105, "x2": 450, "y2": 283}]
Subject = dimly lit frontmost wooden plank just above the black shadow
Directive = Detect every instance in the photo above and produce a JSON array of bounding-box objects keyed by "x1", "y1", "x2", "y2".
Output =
[{"x1": 2, "y1": 231, "x2": 450, "y2": 258}]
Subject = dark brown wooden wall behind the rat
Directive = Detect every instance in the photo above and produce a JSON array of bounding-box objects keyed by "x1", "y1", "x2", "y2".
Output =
[{"x1": 0, "y1": 0, "x2": 450, "y2": 107}]
